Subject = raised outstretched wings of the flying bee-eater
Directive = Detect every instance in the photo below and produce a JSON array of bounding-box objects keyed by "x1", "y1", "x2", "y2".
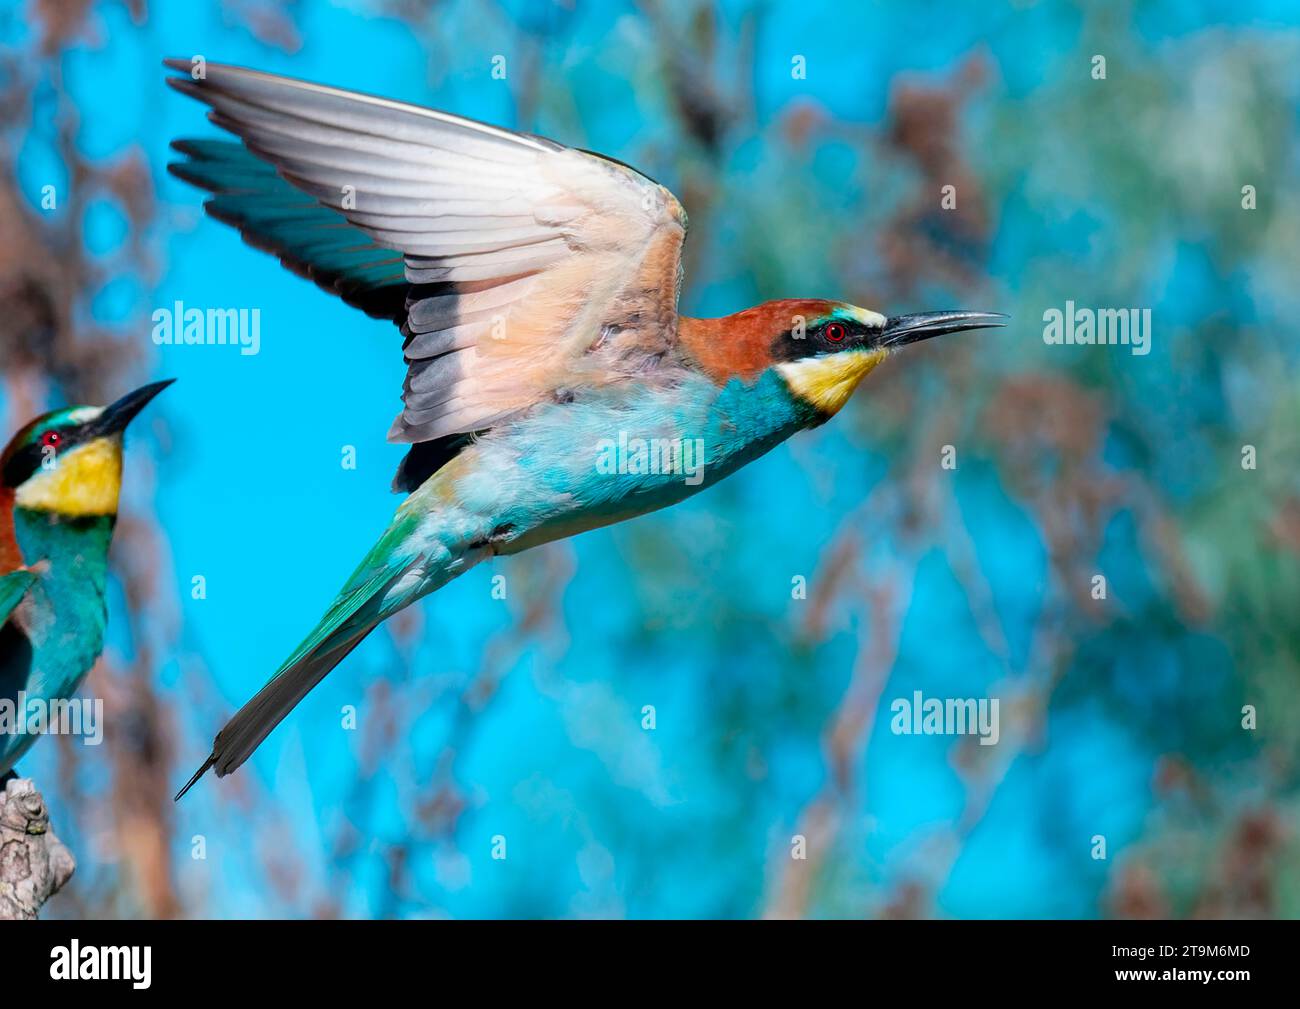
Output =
[{"x1": 166, "y1": 60, "x2": 686, "y2": 443}]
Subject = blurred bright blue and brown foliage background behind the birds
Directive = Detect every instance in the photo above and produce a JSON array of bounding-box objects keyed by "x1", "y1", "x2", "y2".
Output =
[{"x1": 0, "y1": 0, "x2": 1300, "y2": 918}]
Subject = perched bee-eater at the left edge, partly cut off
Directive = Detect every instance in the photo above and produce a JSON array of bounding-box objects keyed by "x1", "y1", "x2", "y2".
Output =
[{"x1": 0, "y1": 381, "x2": 172, "y2": 778}]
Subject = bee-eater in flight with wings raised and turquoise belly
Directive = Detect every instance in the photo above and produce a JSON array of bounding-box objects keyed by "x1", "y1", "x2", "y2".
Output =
[{"x1": 166, "y1": 60, "x2": 1004, "y2": 798}]
